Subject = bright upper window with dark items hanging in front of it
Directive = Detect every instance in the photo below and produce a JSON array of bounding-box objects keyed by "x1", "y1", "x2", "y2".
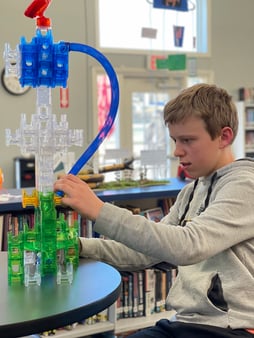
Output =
[{"x1": 98, "y1": 0, "x2": 209, "y2": 54}]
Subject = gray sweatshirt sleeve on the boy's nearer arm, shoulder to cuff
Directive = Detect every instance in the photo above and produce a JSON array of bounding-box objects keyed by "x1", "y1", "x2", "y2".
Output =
[{"x1": 94, "y1": 175, "x2": 254, "y2": 266}]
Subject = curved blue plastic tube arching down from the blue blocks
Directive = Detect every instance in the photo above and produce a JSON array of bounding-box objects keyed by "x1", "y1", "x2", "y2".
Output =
[{"x1": 69, "y1": 42, "x2": 119, "y2": 175}]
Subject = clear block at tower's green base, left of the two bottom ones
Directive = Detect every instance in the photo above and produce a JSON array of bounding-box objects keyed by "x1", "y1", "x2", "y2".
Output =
[{"x1": 24, "y1": 251, "x2": 41, "y2": 286}]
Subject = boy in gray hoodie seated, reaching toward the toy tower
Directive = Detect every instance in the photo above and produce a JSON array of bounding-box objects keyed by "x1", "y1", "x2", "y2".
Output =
[{"x1": 55, "y1": 84, "x2": 254, "y2": 338}]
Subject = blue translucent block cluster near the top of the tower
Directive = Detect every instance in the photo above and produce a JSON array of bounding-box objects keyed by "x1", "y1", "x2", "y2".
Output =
[{"x1": 19, "y1": 29, "x2": 69, "y2": 88}]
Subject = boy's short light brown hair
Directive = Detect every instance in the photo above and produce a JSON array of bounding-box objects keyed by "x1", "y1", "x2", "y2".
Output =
[{"x1": 164, "y1": 83, "x2": 238, "y2": 143}]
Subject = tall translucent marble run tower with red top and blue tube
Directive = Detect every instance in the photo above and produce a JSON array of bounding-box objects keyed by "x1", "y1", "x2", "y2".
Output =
[{"x1": 4, "y1": 0, "x2": 119, "y2": 286}]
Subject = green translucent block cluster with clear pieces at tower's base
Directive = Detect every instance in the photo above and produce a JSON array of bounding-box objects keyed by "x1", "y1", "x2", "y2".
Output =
[{"x1": 8, "y1": 192, "x2": 79, "y2": 286}]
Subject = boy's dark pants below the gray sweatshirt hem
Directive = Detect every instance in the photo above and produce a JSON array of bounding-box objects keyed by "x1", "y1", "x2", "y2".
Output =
[{"x1": 128, "y1": 319, "x2": 254, "y2": 338}]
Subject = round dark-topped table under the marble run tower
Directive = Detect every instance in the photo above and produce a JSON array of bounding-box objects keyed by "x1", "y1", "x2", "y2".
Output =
[{"x1": 0, "y1": 252, "x2": 121, "y2": 338}]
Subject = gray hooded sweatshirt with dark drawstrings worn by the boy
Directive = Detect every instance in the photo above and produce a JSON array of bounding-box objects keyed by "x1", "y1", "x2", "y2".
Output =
[{"x1": 81, "y1": 159, "x2": 254, "y2": 329}]
